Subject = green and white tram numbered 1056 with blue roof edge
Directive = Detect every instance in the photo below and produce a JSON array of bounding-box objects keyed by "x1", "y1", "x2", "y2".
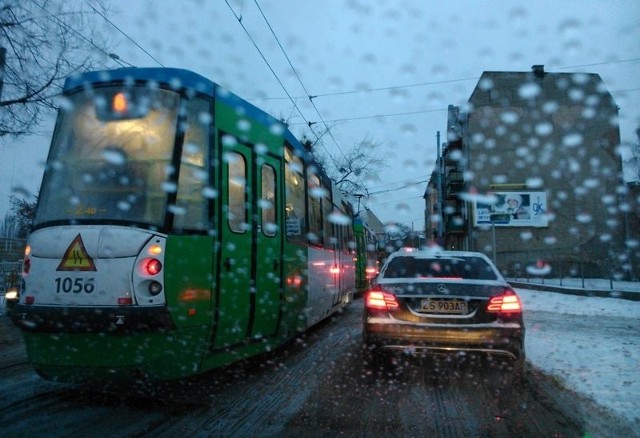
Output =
[{"x1": 12, "y1": 68, "x2": 376, "y2": 382}]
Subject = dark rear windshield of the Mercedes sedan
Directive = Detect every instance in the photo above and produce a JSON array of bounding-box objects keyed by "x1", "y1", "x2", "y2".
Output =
[{"x1": 382, "y1": 257, "x2": 497, "y2": 280}]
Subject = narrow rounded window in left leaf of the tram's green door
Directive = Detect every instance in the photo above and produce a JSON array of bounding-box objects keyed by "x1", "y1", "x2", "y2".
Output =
[{"x1": 226, "y1": 152, "x2": 247, "y2": 233}]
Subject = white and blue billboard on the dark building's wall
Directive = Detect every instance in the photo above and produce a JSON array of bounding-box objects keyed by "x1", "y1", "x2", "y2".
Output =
[{"x1": 473, "y1": 192, "x2": 549, "y2": 227}]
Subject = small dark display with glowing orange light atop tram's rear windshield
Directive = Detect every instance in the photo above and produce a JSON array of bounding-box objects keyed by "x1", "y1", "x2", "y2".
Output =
[{"x1": 94, "y1": 87, "x2": 155, "y2": 122}]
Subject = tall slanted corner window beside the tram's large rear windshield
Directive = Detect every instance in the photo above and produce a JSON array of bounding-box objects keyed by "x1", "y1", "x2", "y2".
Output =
[{"x1": 173, "y1": 99, "x2": 210, "y2": 230}]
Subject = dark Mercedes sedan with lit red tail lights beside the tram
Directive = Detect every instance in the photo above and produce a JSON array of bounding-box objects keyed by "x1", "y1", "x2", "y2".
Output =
[{"x1": 363, "y1": 250, "x2": 525, "y2": 375}]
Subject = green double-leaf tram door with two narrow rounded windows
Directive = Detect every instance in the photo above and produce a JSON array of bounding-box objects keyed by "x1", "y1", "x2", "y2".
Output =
[{"x1": 214, "y1": 143, "x2": 282, "y2": 348}]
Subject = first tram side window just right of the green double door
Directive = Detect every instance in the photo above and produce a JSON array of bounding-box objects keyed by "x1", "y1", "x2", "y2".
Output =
[{"x1": 285, "y1": 147, "x2": 306, "y2": 243}]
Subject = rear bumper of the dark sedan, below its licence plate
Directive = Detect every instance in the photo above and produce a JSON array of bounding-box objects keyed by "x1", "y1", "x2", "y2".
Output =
[{"x1": 363, "y1": 322, "x2": 525, "y2": 361}]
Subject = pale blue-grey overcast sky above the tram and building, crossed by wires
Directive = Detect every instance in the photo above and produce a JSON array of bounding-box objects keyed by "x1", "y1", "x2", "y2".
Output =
[{"x1": 0, "y1": 0, "x2": 640, "y2": 226}]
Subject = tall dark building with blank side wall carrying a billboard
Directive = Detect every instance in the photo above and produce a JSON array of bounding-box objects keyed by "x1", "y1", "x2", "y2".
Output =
[{"x1": 425, "y1": 65, "x2": 631, "y2": 278}]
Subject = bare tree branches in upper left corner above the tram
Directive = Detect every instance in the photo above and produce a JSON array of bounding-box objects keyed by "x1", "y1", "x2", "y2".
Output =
[{"x1": 0, "y1": 0, "x2": 109, "y2": 142}]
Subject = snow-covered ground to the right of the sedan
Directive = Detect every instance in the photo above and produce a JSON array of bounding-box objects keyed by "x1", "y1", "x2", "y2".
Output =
[{"x1": 516, "y1": 280, "x2": 640, "y2": 428}]
